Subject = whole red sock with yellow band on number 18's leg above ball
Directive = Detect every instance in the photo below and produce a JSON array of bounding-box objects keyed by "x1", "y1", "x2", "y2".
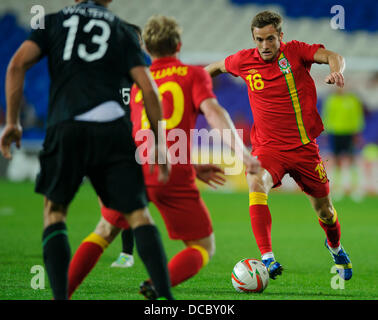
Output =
[{"x1": 249, "y1": 192, "x2": 272, "y2": 255}]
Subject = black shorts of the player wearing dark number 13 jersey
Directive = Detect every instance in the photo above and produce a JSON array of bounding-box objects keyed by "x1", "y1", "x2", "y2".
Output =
[{"x1": 35, "y1": 118, "x2": 148, "y2": 213}]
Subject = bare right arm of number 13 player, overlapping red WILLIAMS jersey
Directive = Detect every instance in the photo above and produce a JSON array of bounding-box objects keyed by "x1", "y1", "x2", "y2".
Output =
[{"x1": 130, "y1": 66, "x2": 170, "y2": 182}]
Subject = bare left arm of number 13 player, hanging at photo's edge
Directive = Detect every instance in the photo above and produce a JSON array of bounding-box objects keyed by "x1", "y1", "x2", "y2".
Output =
[{"x1": 0, "y1": 40, "x2": 41, "y2": 159}]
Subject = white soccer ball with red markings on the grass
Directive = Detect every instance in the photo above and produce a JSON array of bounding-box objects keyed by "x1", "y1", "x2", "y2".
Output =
[{"x1": 231, "y1": 259, "x2": 269, "y2": 292}]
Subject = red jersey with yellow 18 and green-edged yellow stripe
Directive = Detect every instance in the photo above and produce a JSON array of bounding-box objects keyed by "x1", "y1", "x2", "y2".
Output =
[{"x1": 225, "y1": 41, "x2": 324, "y2": 150}]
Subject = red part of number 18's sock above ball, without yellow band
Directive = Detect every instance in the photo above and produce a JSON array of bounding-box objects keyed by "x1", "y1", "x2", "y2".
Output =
[{"x1": 249, "y1": 204, "x2": 272, "y2": 255}]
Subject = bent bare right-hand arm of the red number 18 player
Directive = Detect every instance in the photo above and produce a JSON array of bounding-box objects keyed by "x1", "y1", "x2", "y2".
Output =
[{"x1": 314, "y1": 48, "x2": 345, "y2": 88}]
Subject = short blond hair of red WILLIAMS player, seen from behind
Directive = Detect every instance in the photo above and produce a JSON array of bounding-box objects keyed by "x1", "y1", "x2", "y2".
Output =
[{"x1": 142, "y1": 15, "x2": 182, "y2": 57}]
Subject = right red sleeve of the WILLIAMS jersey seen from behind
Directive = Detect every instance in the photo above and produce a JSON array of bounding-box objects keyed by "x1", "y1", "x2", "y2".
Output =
[{"x1": 192, "y1": 67, "x2": 215, "y2": 109}]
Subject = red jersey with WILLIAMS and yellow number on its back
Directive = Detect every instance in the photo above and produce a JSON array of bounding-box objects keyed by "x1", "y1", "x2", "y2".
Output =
[{"x1": 130, "y1": 57, "x2": 215, "y2": 187}]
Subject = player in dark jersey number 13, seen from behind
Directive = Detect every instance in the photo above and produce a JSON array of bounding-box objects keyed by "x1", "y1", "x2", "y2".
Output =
[{"x1": 0, "y1": 0, "x2": 173, "y2": 299}]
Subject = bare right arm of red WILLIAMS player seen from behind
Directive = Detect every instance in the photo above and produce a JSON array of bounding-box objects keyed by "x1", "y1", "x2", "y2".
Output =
[{"x1": 200, "y1": 98, "x2": 260, "y2": 174}]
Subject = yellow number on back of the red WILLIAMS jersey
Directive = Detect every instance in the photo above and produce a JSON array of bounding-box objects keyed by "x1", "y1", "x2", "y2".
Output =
[{"x1": 134, "y1": 81, "x2": 184, "y2": 130}]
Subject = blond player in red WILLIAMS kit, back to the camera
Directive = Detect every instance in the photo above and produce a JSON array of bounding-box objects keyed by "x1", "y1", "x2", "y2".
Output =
[{"x1": 69, "y1": 16, "x2": 260, "y2": 299}]
